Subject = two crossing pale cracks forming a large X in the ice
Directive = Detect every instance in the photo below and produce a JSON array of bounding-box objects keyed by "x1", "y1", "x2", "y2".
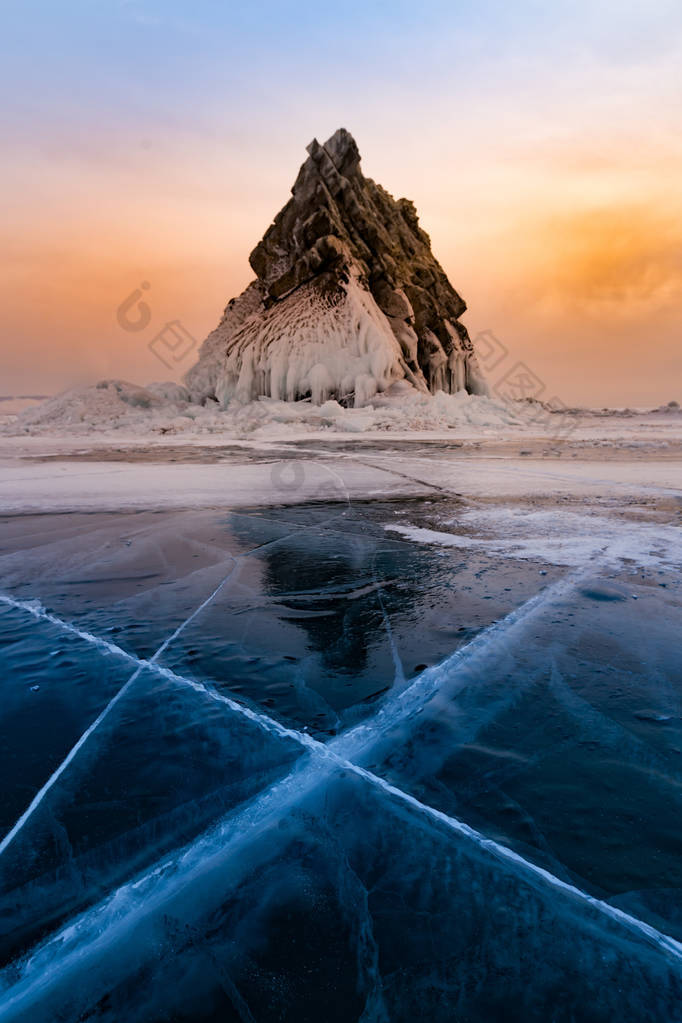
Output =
[{"x1": 2, "y1": 573, "x2": 682, "y2": 1016}]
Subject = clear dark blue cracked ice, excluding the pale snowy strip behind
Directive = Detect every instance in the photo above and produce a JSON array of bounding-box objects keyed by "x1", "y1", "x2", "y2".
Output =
[{"x1": 0, "y1": 508, "x2": 682, "y2": 1021}]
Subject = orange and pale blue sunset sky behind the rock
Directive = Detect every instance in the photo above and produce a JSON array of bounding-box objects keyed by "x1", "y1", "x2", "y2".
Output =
[{"x1": 0, "y1": 0, "x2": 682, "y2": 405}]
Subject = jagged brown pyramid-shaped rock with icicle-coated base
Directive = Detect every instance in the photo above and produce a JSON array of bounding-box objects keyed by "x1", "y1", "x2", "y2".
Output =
[{"x1": 185, "y1": 128, "x2": 487, "y2": 405}]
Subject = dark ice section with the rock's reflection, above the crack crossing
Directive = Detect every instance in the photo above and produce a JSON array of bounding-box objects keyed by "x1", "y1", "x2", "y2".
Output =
[{"x1": 165, "y1": 505, "x2": 559, "y2": 735}]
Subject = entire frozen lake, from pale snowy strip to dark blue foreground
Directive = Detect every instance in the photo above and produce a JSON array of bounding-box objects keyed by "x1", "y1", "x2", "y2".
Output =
[{"x1": 0, "y1": 427, "x2": 682, "y2": 1023}]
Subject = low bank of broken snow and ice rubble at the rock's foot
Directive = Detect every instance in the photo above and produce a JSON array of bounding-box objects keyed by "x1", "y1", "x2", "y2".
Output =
[{"x1": 0, "y1": 380, "x2": 525, "y2": 437}]
